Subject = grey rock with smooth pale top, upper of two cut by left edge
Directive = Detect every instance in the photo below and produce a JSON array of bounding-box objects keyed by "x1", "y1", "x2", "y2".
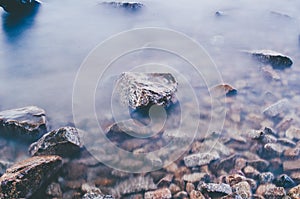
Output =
[{"x1": 0, "y1": 106, "x2": 47, "y2": 142}]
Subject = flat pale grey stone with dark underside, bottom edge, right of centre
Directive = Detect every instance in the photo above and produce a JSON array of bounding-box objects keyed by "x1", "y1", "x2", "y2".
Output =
[{"x1": 198, "y1": 183, "x2": 232, "y2": 195}]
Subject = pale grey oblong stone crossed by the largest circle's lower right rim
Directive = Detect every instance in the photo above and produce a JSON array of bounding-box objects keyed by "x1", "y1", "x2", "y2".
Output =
[{"x1": 183, "y1": 152, "x2": 220, "y2": 167}]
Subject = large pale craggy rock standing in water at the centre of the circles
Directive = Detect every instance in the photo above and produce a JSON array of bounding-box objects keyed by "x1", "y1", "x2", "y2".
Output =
[{"x1": 117, "y1": 72, "x2": 177, "y2": 109}]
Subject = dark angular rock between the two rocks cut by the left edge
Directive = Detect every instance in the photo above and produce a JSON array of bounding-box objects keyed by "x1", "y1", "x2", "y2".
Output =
[{"x1": 29, "y1": 127, "x2": 82, "y2": 157}]
